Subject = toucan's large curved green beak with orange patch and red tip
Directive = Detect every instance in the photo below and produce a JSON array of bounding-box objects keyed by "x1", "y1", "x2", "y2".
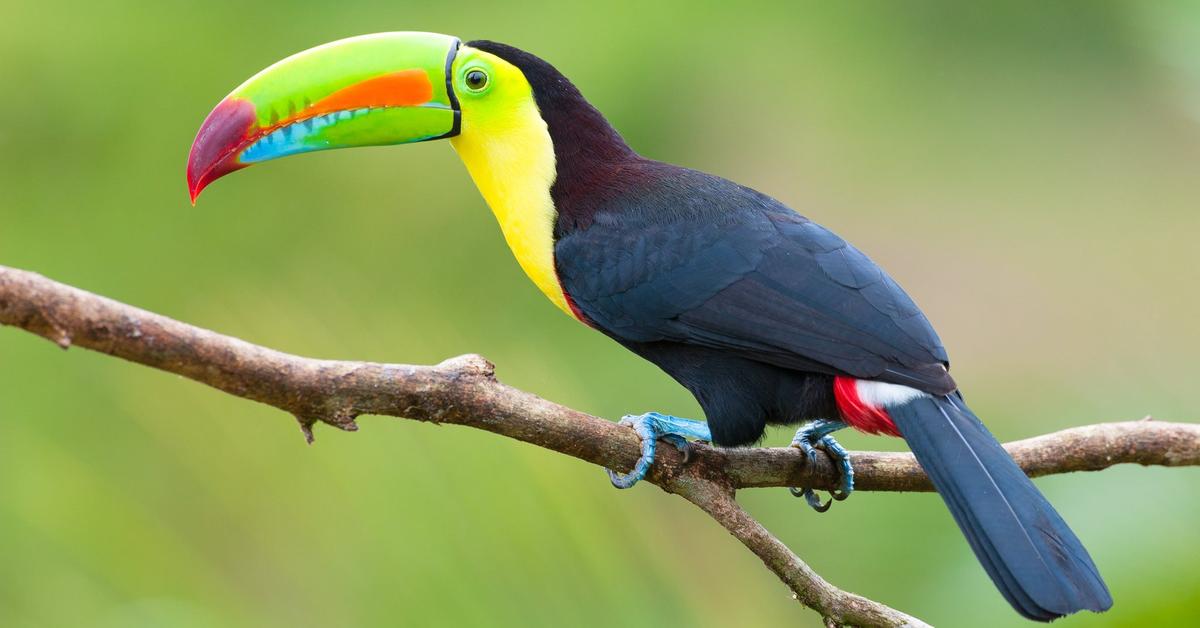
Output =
[{"x1": 187, "y1": 32, "x2": 462, "y2": 203}]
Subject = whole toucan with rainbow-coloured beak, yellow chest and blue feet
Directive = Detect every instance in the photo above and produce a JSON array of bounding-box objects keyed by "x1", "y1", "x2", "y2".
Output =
[{"x1": 187, "y1": 32, "x2": 1112, "y2": 621}]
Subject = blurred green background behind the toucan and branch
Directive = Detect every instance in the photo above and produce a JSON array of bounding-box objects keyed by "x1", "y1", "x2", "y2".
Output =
[{"x1": 0, "y1": 0, "x2": 1200, "y2": 628}]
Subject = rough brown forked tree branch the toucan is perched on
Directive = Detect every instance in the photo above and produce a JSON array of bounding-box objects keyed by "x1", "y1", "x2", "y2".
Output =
[{"x1": 0, "y1": 267, "x2": 1200, "y2": 626}]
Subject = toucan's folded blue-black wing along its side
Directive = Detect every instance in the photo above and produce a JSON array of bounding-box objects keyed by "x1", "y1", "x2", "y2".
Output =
[{"x1": 554, "y1": 169, "x2": 956, "y2": 394}]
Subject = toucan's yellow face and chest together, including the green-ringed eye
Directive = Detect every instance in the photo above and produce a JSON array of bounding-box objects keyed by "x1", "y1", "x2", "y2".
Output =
[{"x1": 450, "y1": 46, "x2": 575, "y2": 318}]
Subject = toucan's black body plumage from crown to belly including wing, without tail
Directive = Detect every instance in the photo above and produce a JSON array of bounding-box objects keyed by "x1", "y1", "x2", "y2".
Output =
[{"x1": 469, "y1": 42, "x2": 955, "y2": 445}]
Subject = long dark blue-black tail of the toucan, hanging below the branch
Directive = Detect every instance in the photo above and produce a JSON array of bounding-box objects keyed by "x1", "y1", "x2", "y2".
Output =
[{"x1": 887, "y1": 394, "x2": 1112, "y2": 621}]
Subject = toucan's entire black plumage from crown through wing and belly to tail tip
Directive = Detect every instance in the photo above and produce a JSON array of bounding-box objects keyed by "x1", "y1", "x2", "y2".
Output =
[{"x1": 469, "y1": 42, "x2": 1111, "y2": 621}]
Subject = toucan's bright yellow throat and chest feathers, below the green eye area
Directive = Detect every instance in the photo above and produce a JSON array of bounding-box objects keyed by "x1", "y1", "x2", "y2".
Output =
[{"x1": 450, "y1": 106, "x2": 575, "y2": 318}]
